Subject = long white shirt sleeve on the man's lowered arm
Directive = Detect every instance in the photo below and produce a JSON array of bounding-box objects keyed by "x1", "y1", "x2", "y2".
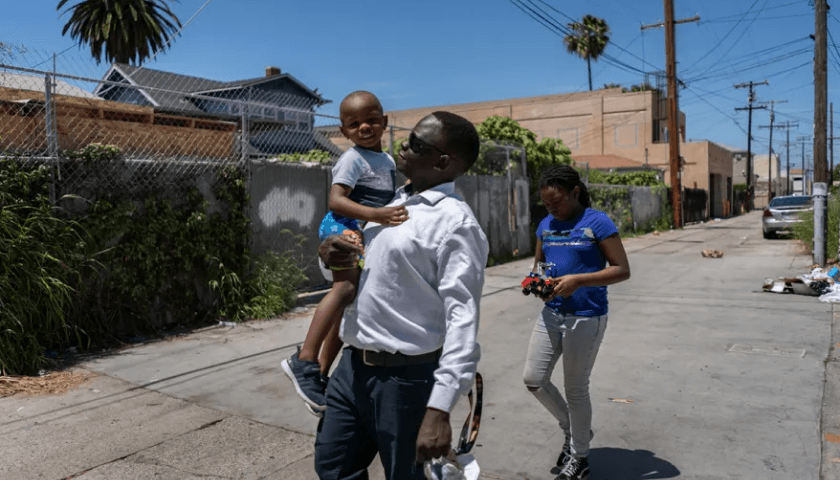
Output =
[{"x1": 426, "y1": 220, "x2": 488, "y2": 412}]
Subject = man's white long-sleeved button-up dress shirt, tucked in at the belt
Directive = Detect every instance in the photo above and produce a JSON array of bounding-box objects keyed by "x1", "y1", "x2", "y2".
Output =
[{"x1": 340, "y1": 182, "x2": 489, "y2": 412}]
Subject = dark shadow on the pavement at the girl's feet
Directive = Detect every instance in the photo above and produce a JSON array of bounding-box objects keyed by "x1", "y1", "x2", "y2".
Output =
[{"x1": 551, "y1": 448, "x2": 680, "y2": 480}]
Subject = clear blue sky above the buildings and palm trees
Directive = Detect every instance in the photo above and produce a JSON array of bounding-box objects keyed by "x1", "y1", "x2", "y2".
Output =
[{"x1": 0, "y1": 0, "x2": 828, "y2": 172}]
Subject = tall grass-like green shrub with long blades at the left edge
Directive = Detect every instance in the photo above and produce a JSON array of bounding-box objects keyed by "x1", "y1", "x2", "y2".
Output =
[{"x1": 0, "y1": 160, "x2": 89, "y2": 374}]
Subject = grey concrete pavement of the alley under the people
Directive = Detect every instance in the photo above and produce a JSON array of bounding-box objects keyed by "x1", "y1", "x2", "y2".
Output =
[{"x1": 0, "y1": 212, "x2": 840, "y2": 480}]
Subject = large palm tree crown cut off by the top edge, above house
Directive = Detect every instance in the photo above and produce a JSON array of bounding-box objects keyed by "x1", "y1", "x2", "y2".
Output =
[{"x1": 56, "y1": 0, "x2": 181, "y2": 65}]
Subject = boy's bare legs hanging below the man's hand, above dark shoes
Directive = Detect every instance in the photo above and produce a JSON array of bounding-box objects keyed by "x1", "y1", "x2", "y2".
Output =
[{"x1": 298, "y1": 268, "x2": 361, "y2": 364}]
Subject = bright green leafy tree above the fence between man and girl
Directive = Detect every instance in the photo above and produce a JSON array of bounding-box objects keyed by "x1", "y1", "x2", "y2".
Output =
[{"x1": 473, "y1": 116, "x2": 572, "y2": 192}]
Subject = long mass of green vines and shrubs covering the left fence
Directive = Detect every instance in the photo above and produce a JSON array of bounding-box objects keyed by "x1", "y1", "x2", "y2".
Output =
[{"x1": 0, "y1": 145, "x2": 305, "y2": 374}]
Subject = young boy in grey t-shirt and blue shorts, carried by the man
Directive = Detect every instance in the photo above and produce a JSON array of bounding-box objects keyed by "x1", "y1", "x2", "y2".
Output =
[{"x1": 282, "y1": 91, "x2": 408, "y2": 417}]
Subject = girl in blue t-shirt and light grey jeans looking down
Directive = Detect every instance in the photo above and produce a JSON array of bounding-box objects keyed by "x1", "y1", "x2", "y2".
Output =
[{"x1": 524, "y1": 165, "x2": 630, "y2": 480}]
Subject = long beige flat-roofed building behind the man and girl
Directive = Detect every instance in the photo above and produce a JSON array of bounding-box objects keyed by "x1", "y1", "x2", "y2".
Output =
[{"x1": 324, "y1": 88, "x2": 732, "y2": 215}]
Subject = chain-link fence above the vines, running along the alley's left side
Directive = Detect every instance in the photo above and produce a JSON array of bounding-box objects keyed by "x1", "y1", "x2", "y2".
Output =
[{"x1": 0, "y1": 48, "x2": 529, "y2": 285}]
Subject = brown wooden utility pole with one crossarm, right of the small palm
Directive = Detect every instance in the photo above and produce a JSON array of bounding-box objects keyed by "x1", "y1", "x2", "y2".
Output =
[{"x1": 642, "y1": 0, "x2": 700, "y2": 228}]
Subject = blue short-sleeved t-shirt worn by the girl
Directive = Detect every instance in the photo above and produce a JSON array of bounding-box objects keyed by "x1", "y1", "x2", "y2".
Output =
[{"x1": 537, "y1": 208, "x2": 618, "y2": 317}]
